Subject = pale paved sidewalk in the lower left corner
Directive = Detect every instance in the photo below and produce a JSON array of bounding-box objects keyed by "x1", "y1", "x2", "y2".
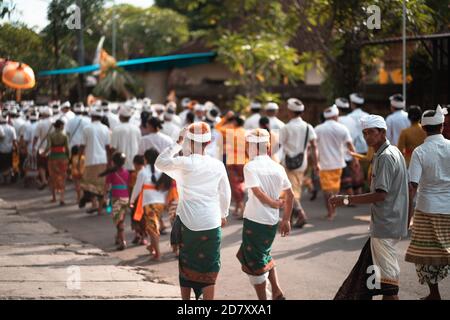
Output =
[{"x1": 0, "y1": 199, "x2": 179, "y2": 299}]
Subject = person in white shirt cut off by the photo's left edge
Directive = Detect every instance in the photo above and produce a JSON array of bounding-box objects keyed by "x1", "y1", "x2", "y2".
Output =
[{"x1": 0, "y1": 113, "x2": 18, "y2": 184}]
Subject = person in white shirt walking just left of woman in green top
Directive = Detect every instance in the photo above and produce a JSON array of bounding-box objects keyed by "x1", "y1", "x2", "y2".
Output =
[{"x1": 33, "y1": 106, "x2": 54, "y2": 189}]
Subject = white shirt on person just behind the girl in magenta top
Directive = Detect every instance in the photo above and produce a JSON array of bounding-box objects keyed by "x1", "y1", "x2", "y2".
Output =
[{"x1": 111, "y1": 123, "x2": 141, "y2": 170}]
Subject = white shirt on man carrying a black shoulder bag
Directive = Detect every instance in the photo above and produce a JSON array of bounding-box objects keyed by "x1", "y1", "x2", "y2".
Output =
[{"x1": 280, "y1": 117, "x2": 317, "y2": 171}]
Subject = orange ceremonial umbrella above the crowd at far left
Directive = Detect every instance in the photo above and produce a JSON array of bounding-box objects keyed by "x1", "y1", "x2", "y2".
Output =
[{"x1": 2, "y1": 61, "x2": 36, "y2": 90}]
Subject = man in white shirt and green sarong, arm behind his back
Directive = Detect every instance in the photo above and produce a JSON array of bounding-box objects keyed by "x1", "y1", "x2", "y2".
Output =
[{"x1": 236, "y1": 129, "x2": 294, "y2": 300}]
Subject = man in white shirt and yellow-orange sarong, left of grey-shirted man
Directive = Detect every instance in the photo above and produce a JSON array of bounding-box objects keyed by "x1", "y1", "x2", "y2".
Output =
[{"x1": 315, "y1": 105, "x2": 355, "y2": 221}]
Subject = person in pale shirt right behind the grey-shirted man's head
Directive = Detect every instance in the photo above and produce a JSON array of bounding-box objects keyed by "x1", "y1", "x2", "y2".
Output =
[{"x1": 386, "y1": 94, "x2": 411, "y2": 146}]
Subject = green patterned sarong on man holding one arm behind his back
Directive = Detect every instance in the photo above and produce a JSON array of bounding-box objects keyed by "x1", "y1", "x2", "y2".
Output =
[{"x1": 236, "y1": 219, "x2": 278, "y2": 276}]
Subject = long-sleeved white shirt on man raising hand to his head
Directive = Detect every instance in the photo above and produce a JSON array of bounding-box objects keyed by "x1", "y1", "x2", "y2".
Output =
[{"x1": 155, "y1": 143, "x2": 231, "y2": 231}]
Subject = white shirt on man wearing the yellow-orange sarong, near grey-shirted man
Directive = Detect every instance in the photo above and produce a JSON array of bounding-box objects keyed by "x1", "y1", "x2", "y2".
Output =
[{"x1": 315, "y1": 120, "x2": 352, "y2": 170}]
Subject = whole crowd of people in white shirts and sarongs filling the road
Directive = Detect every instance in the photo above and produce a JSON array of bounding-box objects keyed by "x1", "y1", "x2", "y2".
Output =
[{"x1": 0, "y1": 93, "x2": 450, "y2": 299}]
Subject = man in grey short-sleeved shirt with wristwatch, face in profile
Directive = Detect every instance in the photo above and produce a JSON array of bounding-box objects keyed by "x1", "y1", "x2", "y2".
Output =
[{"x1": 330, "y1": 115, "x2": 408, "y2": 300}]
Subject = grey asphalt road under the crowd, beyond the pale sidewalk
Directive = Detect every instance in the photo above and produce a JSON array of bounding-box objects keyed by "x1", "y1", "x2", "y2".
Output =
[{"x1": 0, "y1": 185, "x2": 450, "y2": 299}]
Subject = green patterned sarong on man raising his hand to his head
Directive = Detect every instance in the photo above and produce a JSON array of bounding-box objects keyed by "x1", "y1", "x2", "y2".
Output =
[{"x1": 178, "y1": 221, "x2": 222, "y2": 298}]
